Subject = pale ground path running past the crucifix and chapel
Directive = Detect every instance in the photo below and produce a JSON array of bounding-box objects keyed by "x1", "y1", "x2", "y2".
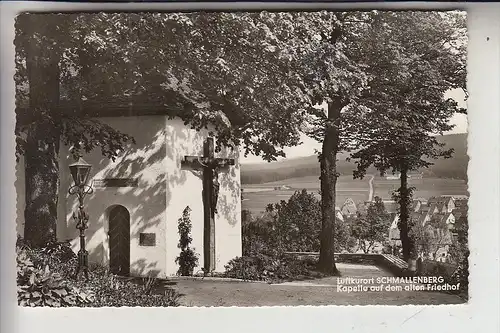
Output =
[{"x1": 162, "y1": 263, "x2": 463, "y2": 306}]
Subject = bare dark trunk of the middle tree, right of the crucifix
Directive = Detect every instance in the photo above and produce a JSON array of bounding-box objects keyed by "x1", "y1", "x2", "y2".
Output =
[{"x1": 318, "y1": 101, "x2": 342, "y2": 275}]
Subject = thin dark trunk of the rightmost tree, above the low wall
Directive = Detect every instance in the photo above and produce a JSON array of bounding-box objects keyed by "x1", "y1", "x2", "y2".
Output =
[{"x1": 399, "y1": 167, "x2": 413, "y2": 261}]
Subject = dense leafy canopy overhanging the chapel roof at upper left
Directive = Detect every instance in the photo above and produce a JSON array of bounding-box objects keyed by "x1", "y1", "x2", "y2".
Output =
[{"x1": 17, "y1": 12, "x2": 308, "y2": 160}]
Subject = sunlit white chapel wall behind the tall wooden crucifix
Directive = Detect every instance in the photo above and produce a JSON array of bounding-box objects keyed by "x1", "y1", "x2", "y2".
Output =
[{"x1": 165, "y1": 119, "x2": 241, "y2": 275}]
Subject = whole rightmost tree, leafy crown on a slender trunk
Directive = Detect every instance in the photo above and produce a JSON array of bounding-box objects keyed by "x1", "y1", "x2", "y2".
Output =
[{"x1": 346, "y1": 12, "x2": 466, "y2": 260}]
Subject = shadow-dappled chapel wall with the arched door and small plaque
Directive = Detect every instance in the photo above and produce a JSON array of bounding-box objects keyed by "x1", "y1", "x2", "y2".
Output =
[{"x1": 59, "y1": 116, "x2": 170, "y2": 277}]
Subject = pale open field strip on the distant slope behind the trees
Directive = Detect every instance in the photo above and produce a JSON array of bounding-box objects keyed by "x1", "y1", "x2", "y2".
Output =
[{"x1": 242, "y1": 176, "x2": 467, "y2": 214}]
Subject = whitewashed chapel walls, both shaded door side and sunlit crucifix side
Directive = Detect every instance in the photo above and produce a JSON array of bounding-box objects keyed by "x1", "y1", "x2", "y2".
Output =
[{"x1": 16, "y1": 115, "x2": 241, "y2": 277}]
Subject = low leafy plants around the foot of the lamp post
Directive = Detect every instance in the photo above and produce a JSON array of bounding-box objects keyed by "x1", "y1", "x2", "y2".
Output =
[{"x1": 17, "y1": 236, "x2": 180, "y2": 307}]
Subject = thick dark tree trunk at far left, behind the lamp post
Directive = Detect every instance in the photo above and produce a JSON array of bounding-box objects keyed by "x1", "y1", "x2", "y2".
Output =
[{"x1": 24, "y1": 17, "x2": 61, "y2": 246}]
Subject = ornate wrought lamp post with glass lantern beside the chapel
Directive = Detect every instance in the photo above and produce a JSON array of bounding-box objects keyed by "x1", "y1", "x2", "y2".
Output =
[{"x1": 68, "y1": 156, "x2": 93, "y2": 281}]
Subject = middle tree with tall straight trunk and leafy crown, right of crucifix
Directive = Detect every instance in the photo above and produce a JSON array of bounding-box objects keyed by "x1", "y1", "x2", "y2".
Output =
[{"x1": 264, "y1": 11, "x2": 370, "y2": 274}]
